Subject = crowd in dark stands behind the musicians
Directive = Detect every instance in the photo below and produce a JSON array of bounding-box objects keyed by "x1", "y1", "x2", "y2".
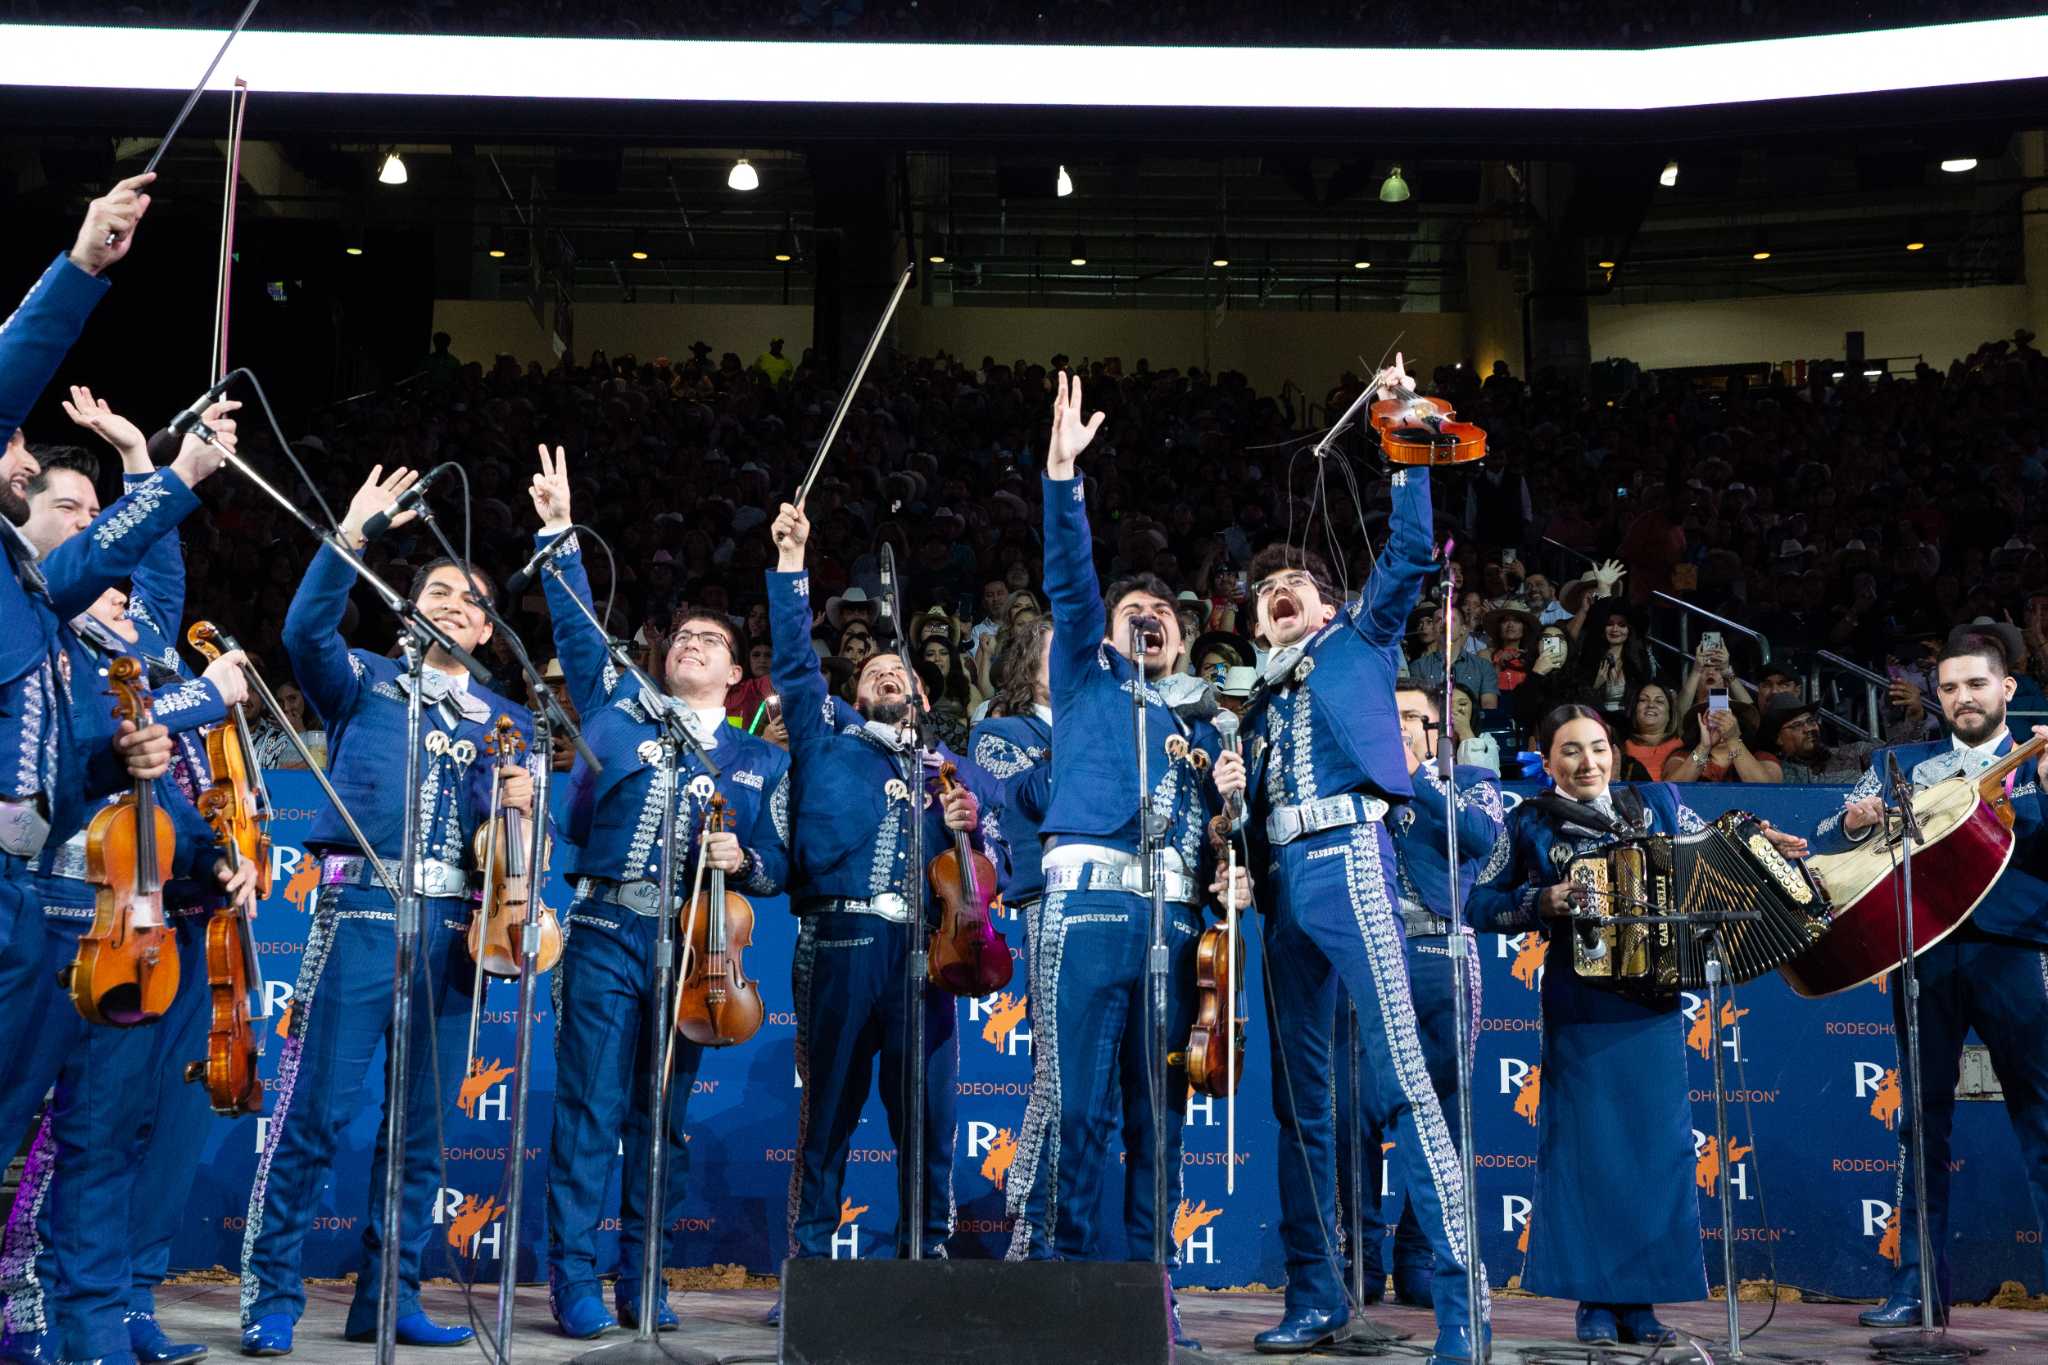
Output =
[{"x1": 43, "y1": 309, "x2": 2048, "y2": 782}]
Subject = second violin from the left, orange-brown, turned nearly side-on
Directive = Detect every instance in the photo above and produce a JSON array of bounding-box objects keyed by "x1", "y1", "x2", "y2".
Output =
[{"x1": 184, "y1": 620, "x2": 274, "y2": 1117}]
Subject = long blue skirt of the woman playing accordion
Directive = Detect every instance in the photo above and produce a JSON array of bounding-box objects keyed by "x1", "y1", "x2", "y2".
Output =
[{"x1": 1522, "y1": 933, "x2": 1706, "y2": 1304}]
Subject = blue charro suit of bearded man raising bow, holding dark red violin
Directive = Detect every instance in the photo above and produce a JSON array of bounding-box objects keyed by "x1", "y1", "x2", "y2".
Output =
[{"x1": 768, "y1": 573, "x2": 995, "y2": 1257}]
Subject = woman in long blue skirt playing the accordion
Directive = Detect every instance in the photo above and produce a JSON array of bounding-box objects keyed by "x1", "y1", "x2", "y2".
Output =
[{"x1": 1470, "y1": 704, "x2": 1806, "y2": 1347}]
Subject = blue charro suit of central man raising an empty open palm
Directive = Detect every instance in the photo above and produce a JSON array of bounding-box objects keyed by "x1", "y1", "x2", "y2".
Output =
[{"x1": 1008, "y1": 479, "x2": 1221, "y2": 1261}]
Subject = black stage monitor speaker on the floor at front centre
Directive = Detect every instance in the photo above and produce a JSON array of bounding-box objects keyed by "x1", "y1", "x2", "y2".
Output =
[{"x1": 778, "y1": 1259, "x2": 1174, "y2": 1365}]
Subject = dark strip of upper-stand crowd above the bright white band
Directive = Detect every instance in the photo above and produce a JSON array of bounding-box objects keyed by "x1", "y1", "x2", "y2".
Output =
[{"x1": 19, "y1": 0, "x2": 2042, "y2": 47}]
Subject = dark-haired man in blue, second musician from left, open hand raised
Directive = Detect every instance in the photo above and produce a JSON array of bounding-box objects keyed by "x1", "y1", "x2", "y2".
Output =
[{"x1": 4, "y1": 437, "x2": 258, "y2": 1361}]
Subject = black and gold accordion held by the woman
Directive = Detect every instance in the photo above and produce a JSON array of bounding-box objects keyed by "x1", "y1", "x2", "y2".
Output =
[{"x1": 1565, "y1": 810, "x2": 1829, "y2": 995}]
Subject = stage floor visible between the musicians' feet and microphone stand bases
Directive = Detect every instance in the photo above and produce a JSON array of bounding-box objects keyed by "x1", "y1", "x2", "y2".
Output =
[{"x1": 158, "y1": 1283, "x2": 2048, "y2": 1365}]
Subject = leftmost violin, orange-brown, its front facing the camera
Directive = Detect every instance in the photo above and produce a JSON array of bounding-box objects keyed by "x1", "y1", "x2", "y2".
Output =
[{"x1": 57, "y1": 655, "x2": 178, "y2": 1027}]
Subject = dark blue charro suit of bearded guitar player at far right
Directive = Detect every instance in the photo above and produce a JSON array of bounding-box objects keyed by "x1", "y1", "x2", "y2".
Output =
[{"x1": 1812, "y1": 735, "x2": 2048, "y2": 1312}]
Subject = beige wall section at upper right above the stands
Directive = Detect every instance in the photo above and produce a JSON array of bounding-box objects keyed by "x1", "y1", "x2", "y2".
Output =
[{"x1": 1591, "y1": 284, "x2": 2028, "y2": 368}]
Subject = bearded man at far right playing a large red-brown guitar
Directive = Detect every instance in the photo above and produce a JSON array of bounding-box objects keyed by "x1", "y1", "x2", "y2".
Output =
[{"x1": 1815, "y1": 626, "x2": 2048, "y2": 1326}]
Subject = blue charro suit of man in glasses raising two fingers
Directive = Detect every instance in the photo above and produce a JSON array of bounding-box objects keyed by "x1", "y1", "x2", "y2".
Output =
[{"x1": 541, "y1": 536, "x2": 788, "y2": 1318}]
